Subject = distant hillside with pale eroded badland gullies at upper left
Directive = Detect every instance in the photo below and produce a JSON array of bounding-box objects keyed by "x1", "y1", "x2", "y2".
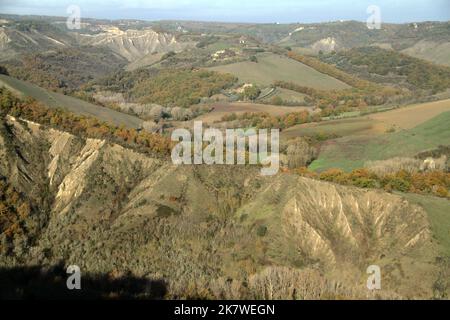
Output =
[{"x1": 0, "y1": 16, "x2": 189, "y2": 61}]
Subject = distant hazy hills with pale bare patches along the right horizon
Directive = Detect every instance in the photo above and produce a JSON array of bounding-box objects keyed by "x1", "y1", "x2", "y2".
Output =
[{"x1": 154, "y1": 21, "x2": 450, "y2": 63}]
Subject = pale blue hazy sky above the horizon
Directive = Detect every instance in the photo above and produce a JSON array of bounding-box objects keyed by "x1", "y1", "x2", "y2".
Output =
[{"x1": 0, "y1": 0, "x2": 450, "y2": 22}]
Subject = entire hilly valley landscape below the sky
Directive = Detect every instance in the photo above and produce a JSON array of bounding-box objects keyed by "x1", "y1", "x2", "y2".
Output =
[{"x1": 0, "y1": 14, "x2": 450, "y2": 300}]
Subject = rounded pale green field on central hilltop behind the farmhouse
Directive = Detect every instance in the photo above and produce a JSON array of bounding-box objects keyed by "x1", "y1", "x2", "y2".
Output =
[{"x1": 210, "y1": 53, "x2": 349, "y2": 90}]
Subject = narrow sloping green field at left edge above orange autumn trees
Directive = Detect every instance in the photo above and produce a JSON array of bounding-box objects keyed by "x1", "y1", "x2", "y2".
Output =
[{"x1": 0, "y1": 75, "x2": 143, "y2": 128}]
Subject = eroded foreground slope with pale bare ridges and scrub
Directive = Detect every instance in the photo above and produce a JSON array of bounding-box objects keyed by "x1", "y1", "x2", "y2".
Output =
[{"x1": 0, "y1": 118, "x2": 440, "y2": 296}]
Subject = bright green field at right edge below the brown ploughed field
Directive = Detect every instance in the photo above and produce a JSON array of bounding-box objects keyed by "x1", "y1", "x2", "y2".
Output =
[{"x1": 310, "y1": 112, "x2": 450, "y2": 171}]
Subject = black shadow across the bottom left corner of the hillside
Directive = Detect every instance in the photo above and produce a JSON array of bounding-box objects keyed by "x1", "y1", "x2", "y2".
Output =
[{"x1": 0, "y1": 266, "x2": 167, "y2": 300}]
